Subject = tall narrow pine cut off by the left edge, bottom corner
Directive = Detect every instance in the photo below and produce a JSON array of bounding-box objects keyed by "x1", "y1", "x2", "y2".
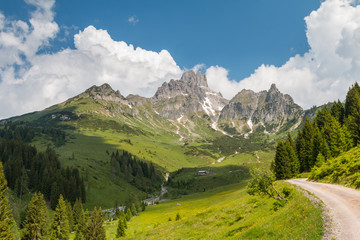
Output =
[{"x1": 0, "y1": 162, "x2": 14, "y2": 239}]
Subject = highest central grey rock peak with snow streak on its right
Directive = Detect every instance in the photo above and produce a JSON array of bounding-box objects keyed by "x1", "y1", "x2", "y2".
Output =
[{"x1": 151, "y1": 70, "x2": 228, "y2": 119}]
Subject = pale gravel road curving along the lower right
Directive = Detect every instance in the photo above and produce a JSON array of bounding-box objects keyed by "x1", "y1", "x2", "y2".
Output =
[{"x1": 288, "y1": 179, "x2": 360, "y2": 240}]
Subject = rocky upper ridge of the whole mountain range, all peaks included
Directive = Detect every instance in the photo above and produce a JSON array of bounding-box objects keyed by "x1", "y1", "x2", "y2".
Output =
[{"x1": 19, "y1": 70, "x2": 304, "y2": 139}]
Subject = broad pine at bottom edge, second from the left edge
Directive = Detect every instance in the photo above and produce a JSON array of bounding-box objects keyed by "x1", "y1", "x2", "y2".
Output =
[{"x1": 22, "y1": 192, "x2": 49, "y2": 240}]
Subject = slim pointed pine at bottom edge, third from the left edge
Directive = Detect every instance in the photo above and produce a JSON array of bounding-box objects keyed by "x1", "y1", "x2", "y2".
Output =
[{"x1": 50, "y1": 195, "x2": 70, "y2": 239}]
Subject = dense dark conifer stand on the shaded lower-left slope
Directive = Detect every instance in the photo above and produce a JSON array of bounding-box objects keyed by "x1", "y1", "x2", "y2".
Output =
[{"x1": 0, "y1": 139, "x2": 86, "y2": 209}]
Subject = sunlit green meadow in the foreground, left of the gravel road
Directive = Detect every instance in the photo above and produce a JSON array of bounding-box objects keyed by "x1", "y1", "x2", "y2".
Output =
[{"x1": 101, "y1": 183, "x2": 323, "y2": 239}]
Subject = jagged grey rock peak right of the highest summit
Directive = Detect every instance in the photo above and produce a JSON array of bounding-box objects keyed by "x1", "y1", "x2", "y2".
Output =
[{"x1": 219, "y1": 84, "x2": 303, "y2": 132}]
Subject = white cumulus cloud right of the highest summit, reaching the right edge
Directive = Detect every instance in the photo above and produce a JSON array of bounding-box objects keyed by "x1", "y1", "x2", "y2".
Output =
[{"x1": 206, "y1": 0, "x2": 360, "y2": 108}]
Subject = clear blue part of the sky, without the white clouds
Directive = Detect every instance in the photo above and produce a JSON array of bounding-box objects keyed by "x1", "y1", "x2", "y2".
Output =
[{"x1": 0, "y1": 0, "x2": 320, "y2": 80}]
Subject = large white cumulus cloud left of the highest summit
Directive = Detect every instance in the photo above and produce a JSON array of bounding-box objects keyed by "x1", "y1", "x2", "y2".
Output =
[{"x1": 0, "y1": 0, "x2": 182, "y2": 118}]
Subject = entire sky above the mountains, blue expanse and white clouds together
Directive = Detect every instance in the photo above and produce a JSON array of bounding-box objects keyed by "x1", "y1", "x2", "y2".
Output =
[{"x1": 0, "y1": 0, "x2": 360, "y2": 118}]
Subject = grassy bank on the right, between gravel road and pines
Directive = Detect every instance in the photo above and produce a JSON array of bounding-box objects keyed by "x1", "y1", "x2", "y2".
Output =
[{"x1": 310, "y1": 147, "x2": 360, "y2": 188}]
